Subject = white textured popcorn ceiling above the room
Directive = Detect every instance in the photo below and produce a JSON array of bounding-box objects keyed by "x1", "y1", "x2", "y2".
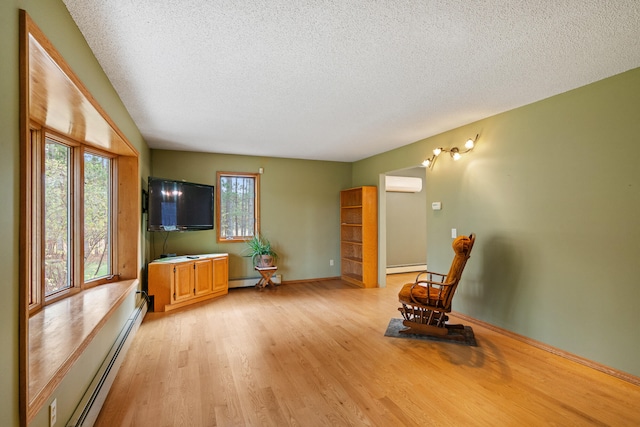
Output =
[{"x1": 63, "y1": 0, "x2": 640, "y2": 161}]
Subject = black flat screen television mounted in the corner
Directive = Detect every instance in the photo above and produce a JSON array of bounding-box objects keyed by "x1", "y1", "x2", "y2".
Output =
[{"x1": 147, "y1": 177, "x2": 214, "y2": 231}]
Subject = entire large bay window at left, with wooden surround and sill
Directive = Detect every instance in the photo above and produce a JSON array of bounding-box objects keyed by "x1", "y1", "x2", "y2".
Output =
[{"x1": 18, "y1": 10, "x2": 141, "y2": 425}]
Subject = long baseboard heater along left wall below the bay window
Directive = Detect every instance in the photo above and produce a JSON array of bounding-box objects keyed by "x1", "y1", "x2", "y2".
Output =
[{"x1": 67, "y1": 298, "x2": 148, "y2": 427}]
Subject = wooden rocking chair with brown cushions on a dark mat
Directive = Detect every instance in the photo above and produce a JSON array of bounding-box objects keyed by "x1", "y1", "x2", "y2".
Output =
[{"x1": 398, "y1": 234, "x2": 475, "y2": 339}]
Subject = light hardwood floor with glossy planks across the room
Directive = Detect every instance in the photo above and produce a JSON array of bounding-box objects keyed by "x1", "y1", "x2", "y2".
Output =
[{"x1": 96, "y1": 273, "x2": 640, "y2": 427}]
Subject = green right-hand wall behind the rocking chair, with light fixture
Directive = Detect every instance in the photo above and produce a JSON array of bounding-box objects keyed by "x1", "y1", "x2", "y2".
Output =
[{"x1": 353, "y1": 69, "x2": 640, "y2": 375}]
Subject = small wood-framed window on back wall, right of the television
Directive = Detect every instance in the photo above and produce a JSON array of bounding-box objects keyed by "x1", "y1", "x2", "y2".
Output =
[{"x1": 216, "y1": 172, "x2": 260, "y2": 242}]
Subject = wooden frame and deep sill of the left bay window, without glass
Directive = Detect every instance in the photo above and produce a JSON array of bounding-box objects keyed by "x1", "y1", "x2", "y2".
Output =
[{"x1": 18, "y1": 10, "x2": 142, "y2": 425}]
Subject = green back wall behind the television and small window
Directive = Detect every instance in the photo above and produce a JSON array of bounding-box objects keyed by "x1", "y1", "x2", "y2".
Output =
[{"x1": 148, "y1": 150, "x2": 351, "y2": 281}]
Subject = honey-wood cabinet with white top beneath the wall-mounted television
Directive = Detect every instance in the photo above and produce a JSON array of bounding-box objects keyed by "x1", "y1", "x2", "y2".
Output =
[{"x1": 148, "y1": 254, "x2": 229, "y2": 311}]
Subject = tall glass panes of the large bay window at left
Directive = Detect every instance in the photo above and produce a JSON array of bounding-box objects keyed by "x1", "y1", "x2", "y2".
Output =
[{"x1": 29, "y1": 133, "x2": 114, "y2": 312}]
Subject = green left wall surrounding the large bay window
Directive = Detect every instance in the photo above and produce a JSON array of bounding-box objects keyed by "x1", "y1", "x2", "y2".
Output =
[{"x1": 0, "y1": 0, "x2": 150, "y2": 426}]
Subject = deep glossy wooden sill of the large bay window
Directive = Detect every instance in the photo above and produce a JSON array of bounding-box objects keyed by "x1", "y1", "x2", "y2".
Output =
[{"x1": 28, "y1": 279, "x2": 138, "y2": 409}]
